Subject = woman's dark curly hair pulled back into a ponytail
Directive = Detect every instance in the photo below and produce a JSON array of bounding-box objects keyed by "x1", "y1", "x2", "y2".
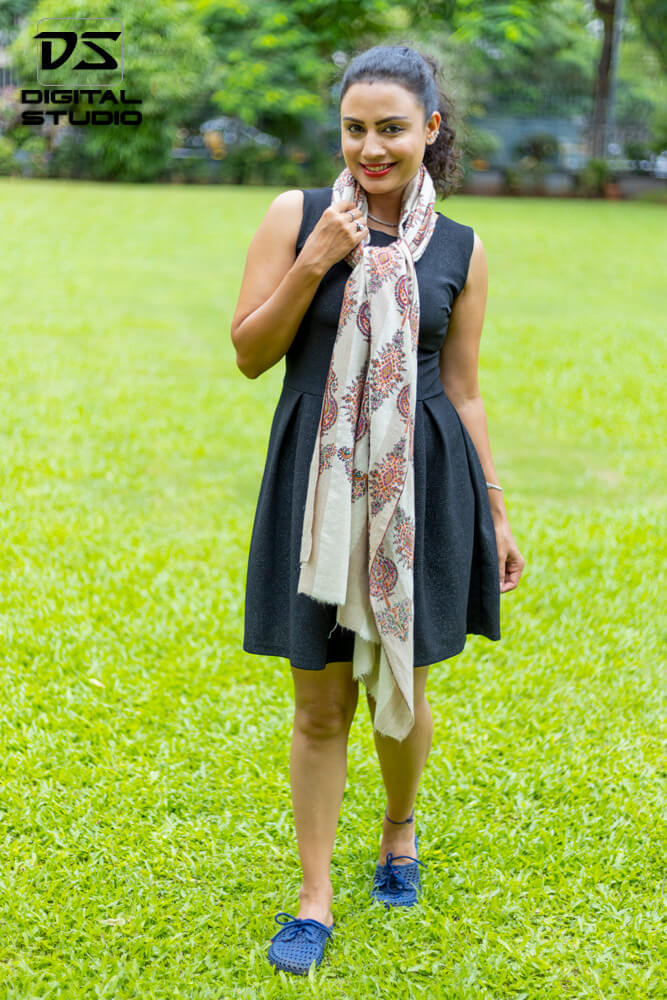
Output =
[{"x1": 339, "y1": 45, "x2": 463, "y2": 198}]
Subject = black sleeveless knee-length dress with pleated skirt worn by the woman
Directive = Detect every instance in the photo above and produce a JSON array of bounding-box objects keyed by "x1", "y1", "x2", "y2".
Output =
[{"x1": 243, "y1": 187, "x2": 500, "y2": 670}]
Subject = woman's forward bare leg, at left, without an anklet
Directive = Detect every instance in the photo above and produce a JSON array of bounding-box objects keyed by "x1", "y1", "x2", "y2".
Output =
[{"x1": 290, "y1": 662, "x2": 359, "y2": 926}]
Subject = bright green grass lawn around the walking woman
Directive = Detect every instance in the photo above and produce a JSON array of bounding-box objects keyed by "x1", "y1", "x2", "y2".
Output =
[{"x1": 0, "y1": 179, "x2": 667, "y2": 1000}]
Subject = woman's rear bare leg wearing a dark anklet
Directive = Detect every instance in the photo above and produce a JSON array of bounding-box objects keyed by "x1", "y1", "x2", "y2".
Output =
[{"x1": 366, "y1": 667, "x2": 433, "y2": 865}]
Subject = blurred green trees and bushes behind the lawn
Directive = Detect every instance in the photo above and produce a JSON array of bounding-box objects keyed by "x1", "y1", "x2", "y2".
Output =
[{"x1": 0, "y1": 0, "x2": 667, "y2": 185}]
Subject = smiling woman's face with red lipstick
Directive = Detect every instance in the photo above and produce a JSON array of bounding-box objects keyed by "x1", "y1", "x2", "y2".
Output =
[{"x1": 340, "y1": 82, "x2": 440, "y2": 195}]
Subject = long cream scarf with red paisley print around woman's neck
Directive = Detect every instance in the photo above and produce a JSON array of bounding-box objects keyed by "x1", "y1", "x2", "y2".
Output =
[{"x1": 298, "y1": 163, "x2": 437, "y2": 740}]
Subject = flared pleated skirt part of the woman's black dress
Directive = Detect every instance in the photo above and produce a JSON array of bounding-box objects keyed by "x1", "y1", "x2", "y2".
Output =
[{"x1": 243, "y1": 381, "x2": 500, "y2": 670}]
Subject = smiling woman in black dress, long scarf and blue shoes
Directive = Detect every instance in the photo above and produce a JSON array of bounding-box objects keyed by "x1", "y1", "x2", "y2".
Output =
[{"x1": 232, "y1": 46, "x2": 524, "y2": 974}]
